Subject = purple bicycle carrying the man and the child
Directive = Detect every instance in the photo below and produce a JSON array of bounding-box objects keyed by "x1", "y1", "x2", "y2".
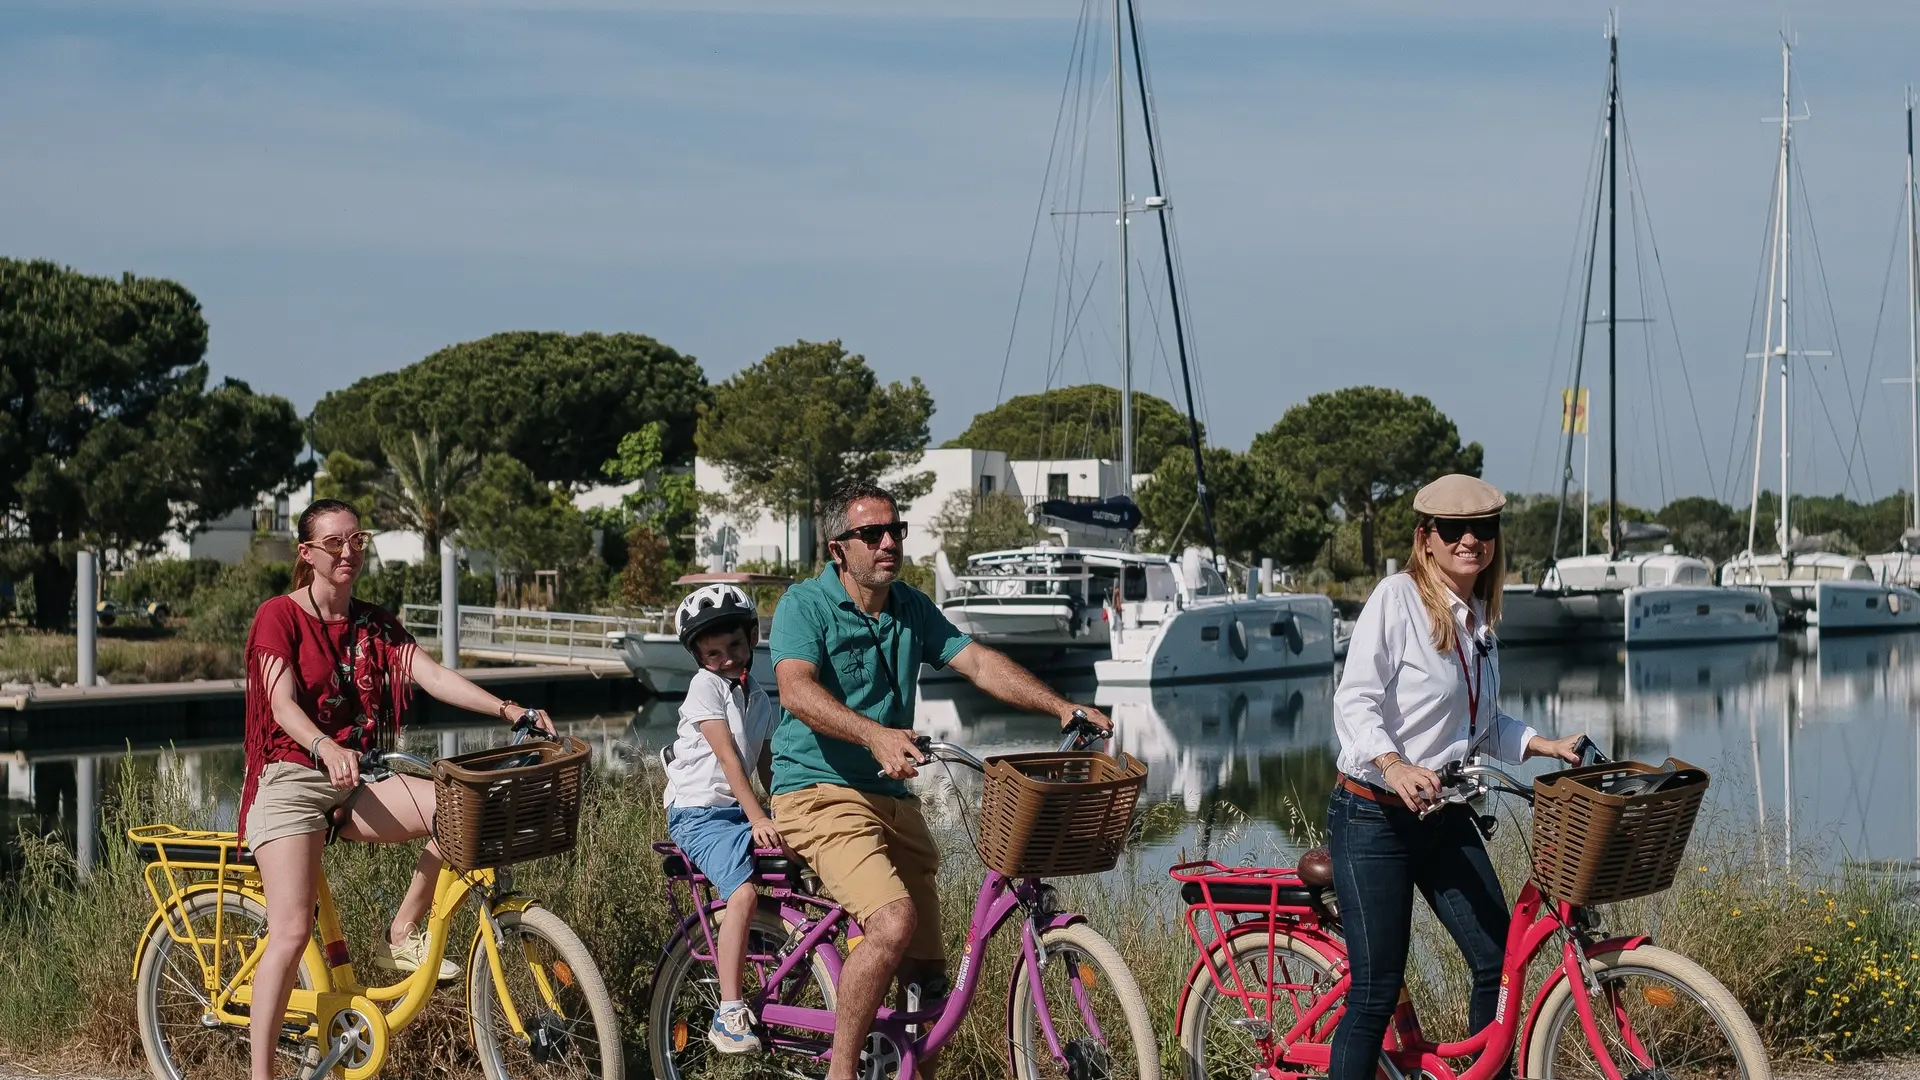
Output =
[{"x1": 647, "y1": 724, "x2": 1160, "y2": 1080}]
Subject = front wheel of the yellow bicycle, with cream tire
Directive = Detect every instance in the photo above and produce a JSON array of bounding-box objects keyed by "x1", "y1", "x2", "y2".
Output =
[{"x1": 467, "y1": 907, "x2": 626, "y2": 1080}]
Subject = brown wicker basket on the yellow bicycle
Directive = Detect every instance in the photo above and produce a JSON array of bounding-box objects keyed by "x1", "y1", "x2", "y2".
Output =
[{"x1": 434, "y1": 736, "x2": 588, "y2": 871}]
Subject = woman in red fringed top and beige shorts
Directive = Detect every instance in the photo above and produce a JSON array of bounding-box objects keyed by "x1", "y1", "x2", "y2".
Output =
[{"x1": 240, "y1": 500, "x2": 553, "y2": 1080}]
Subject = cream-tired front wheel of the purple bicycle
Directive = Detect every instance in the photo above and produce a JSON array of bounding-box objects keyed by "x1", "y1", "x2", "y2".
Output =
[{"x1": 1006, "y1": 922, "x2": 1160, "y2": 1080}]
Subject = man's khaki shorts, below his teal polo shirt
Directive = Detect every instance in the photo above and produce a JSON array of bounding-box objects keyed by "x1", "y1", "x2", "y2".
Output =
[{"x1": 774, "y1": 784, "x2": 947, "y2": 963}]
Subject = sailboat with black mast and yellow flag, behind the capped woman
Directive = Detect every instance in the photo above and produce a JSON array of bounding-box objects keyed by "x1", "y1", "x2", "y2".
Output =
[{"x1": 1500, "y1": 19, "x2": 1780, "y2": 646}]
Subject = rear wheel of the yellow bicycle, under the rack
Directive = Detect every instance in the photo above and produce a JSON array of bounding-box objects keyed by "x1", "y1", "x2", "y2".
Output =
[{"x1": 134, "y1": 892, "x2": 317, "y2": 1080}]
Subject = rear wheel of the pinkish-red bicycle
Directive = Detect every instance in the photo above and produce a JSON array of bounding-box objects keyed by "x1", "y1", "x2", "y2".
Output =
[{"x1": 1181, "y1": 932, "x2": 1340, "y2": 1080}]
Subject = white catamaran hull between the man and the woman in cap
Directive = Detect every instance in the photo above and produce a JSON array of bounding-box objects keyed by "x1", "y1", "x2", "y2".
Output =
[{"x1": 1092, "y1": 594, "x2": 1332, "y2": 686}]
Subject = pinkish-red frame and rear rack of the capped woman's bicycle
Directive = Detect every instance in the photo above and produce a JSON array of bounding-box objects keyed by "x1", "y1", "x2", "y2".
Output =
[{"x1": 1177, "y1": 867, "x2": 1651, "y2": 1080}]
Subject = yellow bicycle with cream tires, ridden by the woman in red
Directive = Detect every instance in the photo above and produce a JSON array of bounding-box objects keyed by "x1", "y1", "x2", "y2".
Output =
[{"x1": 129, "y1": 738, "x2": 624, "y2": 1080}]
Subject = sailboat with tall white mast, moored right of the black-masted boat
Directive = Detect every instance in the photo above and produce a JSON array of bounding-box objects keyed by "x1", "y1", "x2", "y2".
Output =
[{"x1": 1720, "y1": 38, "x2": 1920, "y2": 634}]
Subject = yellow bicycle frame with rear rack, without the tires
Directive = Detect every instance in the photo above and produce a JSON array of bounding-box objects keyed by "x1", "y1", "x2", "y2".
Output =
[{"x1": 129, "y1": 824, "x2": 557, "y2": 1072}]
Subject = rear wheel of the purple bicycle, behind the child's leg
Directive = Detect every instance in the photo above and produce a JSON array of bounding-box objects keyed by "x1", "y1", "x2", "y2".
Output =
[{"x1": 647, "y1": 907, "x2": 833, "y2": 1080}]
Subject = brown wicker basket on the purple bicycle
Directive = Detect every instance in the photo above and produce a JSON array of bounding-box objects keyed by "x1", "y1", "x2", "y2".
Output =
[{"x1": 979, "y1": 753, "x2": 1146, "y2": 878}]
